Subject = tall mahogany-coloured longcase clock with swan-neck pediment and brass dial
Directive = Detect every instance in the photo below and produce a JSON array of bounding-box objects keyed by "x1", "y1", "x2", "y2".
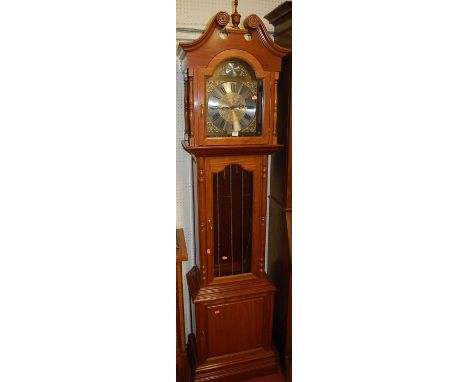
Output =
[{"x1": 179, "y1": 1, "x2": 289, "y2": 381}]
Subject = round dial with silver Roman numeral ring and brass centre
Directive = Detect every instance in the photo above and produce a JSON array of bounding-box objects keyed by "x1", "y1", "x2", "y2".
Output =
[{"x1": 208, "y1": 81, "x2": 257, "y2": 135}]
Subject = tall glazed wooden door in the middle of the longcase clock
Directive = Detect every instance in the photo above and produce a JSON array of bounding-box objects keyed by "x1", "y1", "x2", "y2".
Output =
[{"x1": 206, "y1": 156, "x2": 261, "y2": 282}]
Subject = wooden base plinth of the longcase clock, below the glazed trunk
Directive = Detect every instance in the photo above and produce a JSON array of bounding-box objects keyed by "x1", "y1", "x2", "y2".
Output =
[{"x1": 187, "y1": 267, "x2": 277, "y2": 381}]
